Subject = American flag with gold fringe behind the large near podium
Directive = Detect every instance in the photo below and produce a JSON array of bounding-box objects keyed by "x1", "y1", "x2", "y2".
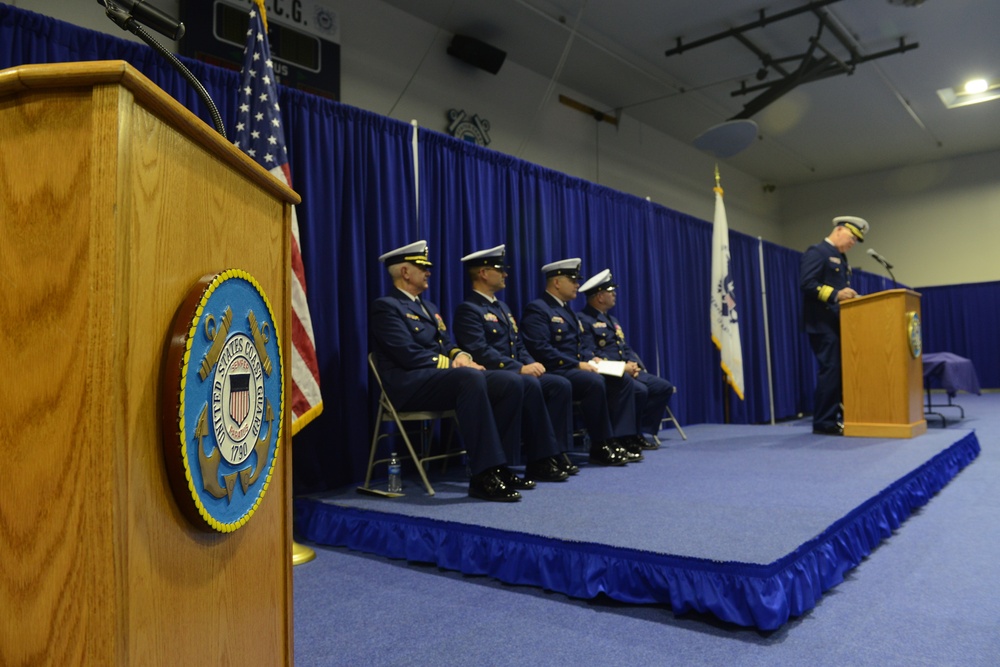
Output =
[{"x1": 233, "y1": 0, "x2": 323, "y2": 435}]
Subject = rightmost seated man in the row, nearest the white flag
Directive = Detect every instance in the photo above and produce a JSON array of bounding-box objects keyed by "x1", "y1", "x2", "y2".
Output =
[{"x1": 577, "y1": 269, "x2": 674, "y2": 449}]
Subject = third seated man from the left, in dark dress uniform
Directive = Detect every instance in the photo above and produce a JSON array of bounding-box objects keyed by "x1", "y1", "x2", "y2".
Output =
[{"x1": 521, "y1": 257, "x2": 642, "y2": 466}]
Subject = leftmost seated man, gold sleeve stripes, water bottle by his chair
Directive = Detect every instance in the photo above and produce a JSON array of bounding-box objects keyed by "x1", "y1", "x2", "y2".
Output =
[{"x1": 369, "y1": 241, "x2": 523, "y2": 501}]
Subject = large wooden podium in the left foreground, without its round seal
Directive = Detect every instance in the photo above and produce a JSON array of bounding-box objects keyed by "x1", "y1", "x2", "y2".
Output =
[{"x1": 0, "y1": 62, "x2": 298, "y2": 667}]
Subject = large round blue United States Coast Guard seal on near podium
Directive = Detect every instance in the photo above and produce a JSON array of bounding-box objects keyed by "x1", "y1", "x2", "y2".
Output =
[{"x1": 162, "y1": 269, "x2": 284, "y2": 533}]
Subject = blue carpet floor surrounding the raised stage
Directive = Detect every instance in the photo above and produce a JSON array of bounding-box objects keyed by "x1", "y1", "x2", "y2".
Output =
[{"x1": 293, "y1": 394, "x2": 1000, "y2": 667}]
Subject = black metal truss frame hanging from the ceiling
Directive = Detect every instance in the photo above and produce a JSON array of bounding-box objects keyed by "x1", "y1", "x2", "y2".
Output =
[{"x1": 665, "y1": 0, "x2": 920, "y2": 120}]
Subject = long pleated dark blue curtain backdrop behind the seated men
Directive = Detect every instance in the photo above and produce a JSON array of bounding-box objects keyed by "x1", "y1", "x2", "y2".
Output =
[{"x1": 7, "y1": 4, "x2": 1000, "y2": 493}]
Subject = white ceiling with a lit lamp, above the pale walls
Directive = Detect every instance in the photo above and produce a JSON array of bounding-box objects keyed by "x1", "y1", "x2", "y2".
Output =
[{"x1": 376, "y1": 0, "x2": 1000, "y2": 185}]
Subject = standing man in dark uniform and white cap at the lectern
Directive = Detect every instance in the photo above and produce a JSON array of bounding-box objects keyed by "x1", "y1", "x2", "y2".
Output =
[{"x1": 799, "y1": 215, "x2": 868, "y2": 435}]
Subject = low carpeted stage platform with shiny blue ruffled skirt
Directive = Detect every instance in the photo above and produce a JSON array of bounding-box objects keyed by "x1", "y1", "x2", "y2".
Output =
[{"x1": 295, "y1": 422, "x2": 979, "y2": 630}]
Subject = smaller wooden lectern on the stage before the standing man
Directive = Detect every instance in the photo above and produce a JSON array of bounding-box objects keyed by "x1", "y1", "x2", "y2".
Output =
[{"x1": 840, "y1": 289, "x2": 927, "y2": 438}]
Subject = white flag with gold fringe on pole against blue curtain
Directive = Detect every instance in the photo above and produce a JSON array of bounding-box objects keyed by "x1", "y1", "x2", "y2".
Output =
[{"x1": 711, "y1": 171, "x2": 743, "y2": 401}]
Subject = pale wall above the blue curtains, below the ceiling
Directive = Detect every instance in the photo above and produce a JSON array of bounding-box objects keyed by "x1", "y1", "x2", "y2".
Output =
[{"x1": 21, "y1": 0, "x2": 1000, "y2": 286}]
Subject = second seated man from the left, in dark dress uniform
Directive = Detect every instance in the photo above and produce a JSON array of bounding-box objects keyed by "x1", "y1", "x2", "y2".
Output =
[{"x1": 454, "y1": 245, "x2": 579, "y2": 484}]
